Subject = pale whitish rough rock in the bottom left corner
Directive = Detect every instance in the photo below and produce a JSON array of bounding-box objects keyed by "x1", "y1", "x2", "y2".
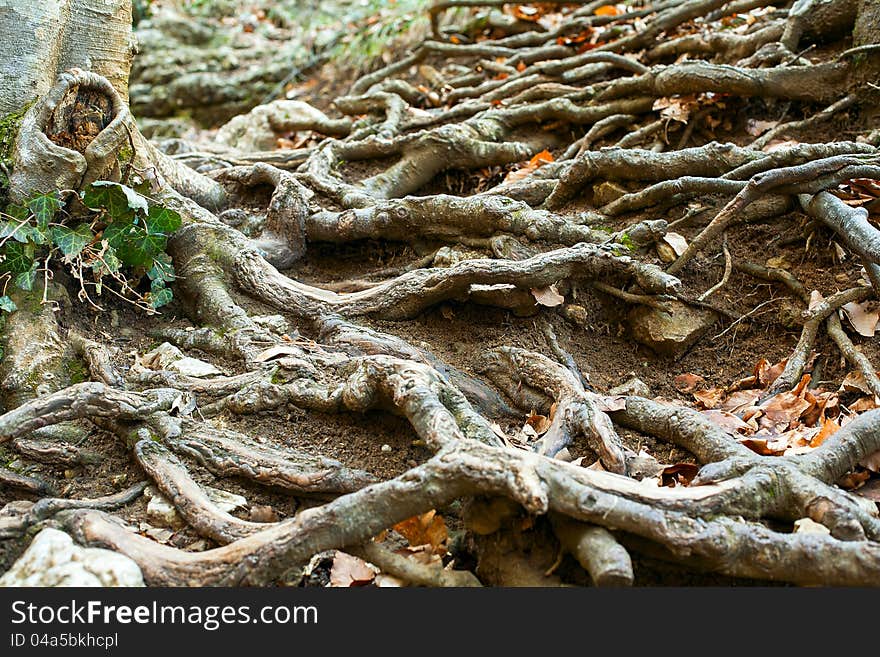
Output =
[{"x1": 0, "y1": 528, "x2": 144, "y2": 587}]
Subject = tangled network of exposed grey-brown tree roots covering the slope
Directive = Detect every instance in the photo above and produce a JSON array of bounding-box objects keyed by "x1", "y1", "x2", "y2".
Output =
[{"x1": 0, "y1": 0, "x2": 880, "y2": 586}]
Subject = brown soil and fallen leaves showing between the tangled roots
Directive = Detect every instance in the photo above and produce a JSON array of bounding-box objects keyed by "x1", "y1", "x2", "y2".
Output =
[{"x1": 0, "y1": 3, "x2": 880, "y2": 585}]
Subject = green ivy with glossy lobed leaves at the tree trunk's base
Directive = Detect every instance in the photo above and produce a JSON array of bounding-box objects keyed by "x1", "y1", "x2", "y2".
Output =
[{"x1": 0, "y1": 181, "x2": 181, "y2": 312}]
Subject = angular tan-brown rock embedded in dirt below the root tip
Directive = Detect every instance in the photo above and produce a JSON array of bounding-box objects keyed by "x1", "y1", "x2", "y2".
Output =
[{"x1": 629, "y1": 301, "x2": 718, "y2": 356}]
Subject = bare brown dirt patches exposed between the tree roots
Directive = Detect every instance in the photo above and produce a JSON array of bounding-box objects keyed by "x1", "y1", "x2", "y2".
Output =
[{"x1": 0, "y1": 0, "x2": 880, "y2": 586}]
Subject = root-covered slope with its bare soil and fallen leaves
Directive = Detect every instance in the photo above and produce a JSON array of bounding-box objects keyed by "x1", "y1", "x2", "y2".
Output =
[{"x1": 0, "y1": 0, "x2": 880, "y2": 586}]
